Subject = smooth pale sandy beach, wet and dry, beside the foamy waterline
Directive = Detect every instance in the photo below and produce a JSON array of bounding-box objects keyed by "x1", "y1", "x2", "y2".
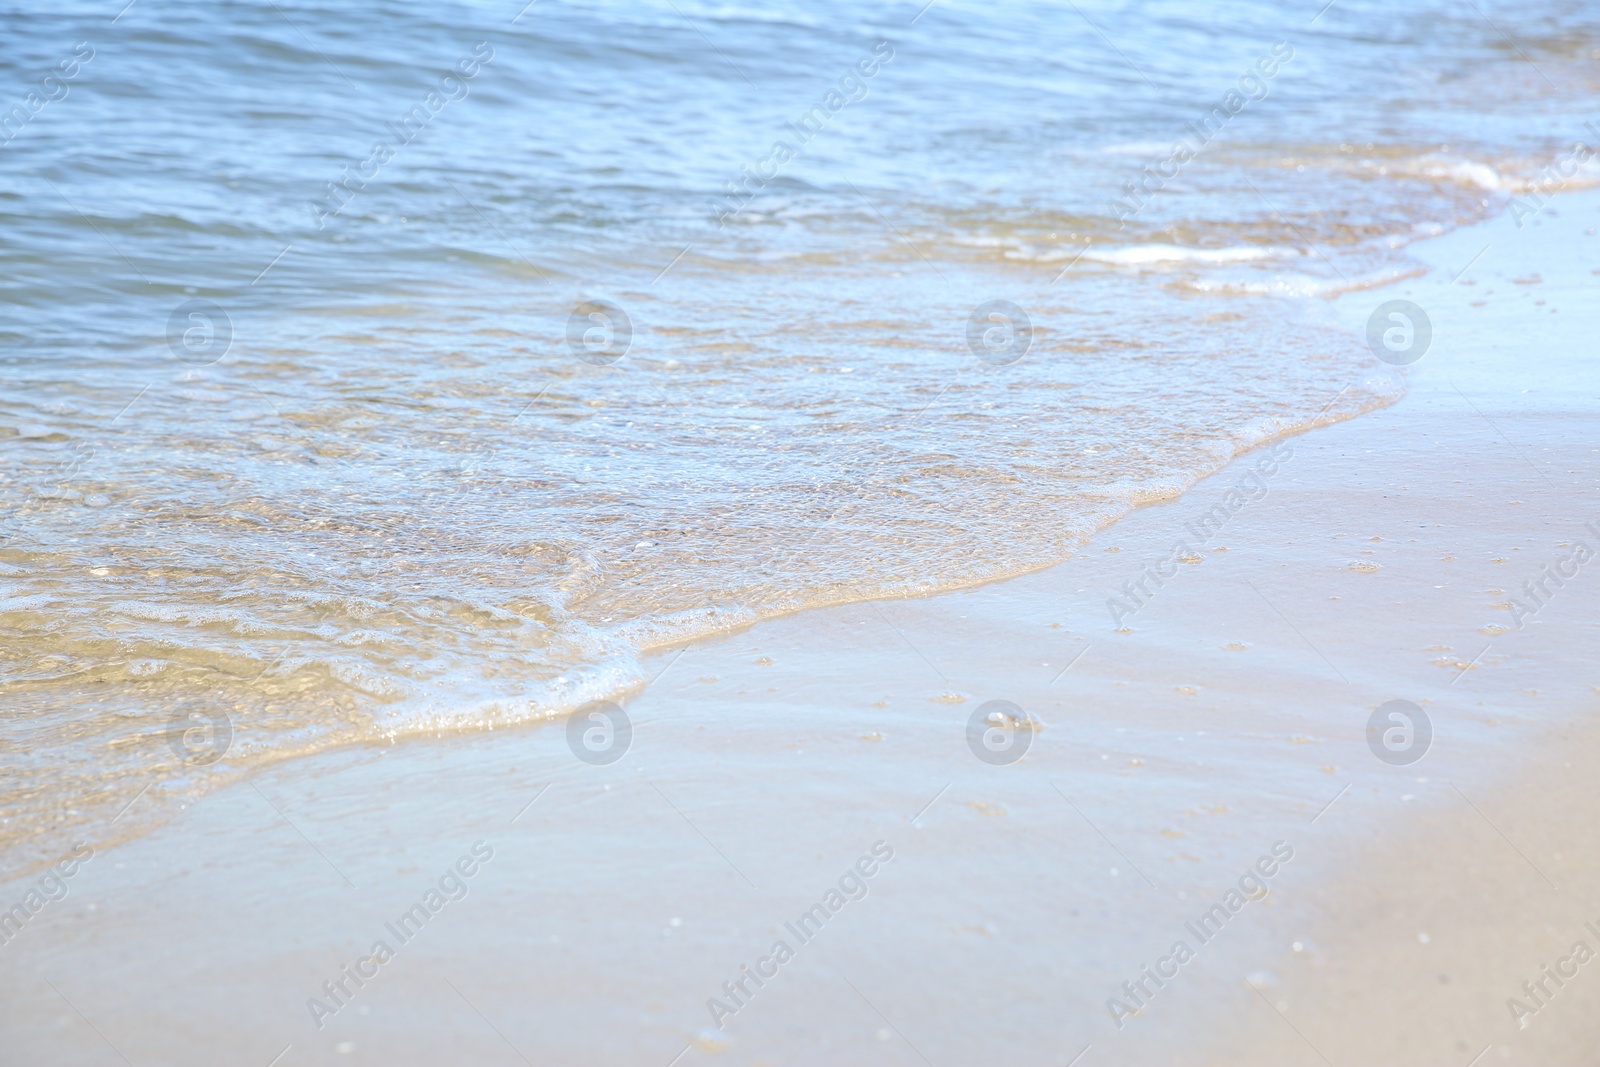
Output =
[{"x1": 0, "y1": 164, "x2": 1600, "y2": 1067}]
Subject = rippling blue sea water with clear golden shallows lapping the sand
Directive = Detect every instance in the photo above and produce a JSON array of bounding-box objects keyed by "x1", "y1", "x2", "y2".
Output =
[{"x1": 0, "y1": 0, "x2": 1600, "y2": 867}]
